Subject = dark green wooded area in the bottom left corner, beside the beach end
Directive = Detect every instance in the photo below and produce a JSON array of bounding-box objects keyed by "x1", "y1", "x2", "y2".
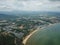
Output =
[{"x1": 0, "y1": 31, "x2": 23, "y2": 45}]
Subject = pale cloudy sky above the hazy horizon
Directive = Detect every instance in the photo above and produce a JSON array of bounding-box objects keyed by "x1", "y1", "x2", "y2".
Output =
[{"x1": 0, "y1": 0, "x2": 60, "y2": 11}]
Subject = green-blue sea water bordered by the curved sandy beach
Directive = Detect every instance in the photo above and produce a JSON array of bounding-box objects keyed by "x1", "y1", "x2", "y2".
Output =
[{"x1": 26, "y1": 23, "x2": 60, "y2": 45}]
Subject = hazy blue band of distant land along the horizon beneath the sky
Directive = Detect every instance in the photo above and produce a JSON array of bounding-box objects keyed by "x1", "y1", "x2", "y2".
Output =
[{"x1": 0, "y1": 11, "x2": 60, "y2": 16}]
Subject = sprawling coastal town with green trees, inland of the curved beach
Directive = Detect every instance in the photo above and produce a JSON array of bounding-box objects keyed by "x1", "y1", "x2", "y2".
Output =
[{"x1": 0, "y1": 16, "x2": 60, "y2": 45}]
